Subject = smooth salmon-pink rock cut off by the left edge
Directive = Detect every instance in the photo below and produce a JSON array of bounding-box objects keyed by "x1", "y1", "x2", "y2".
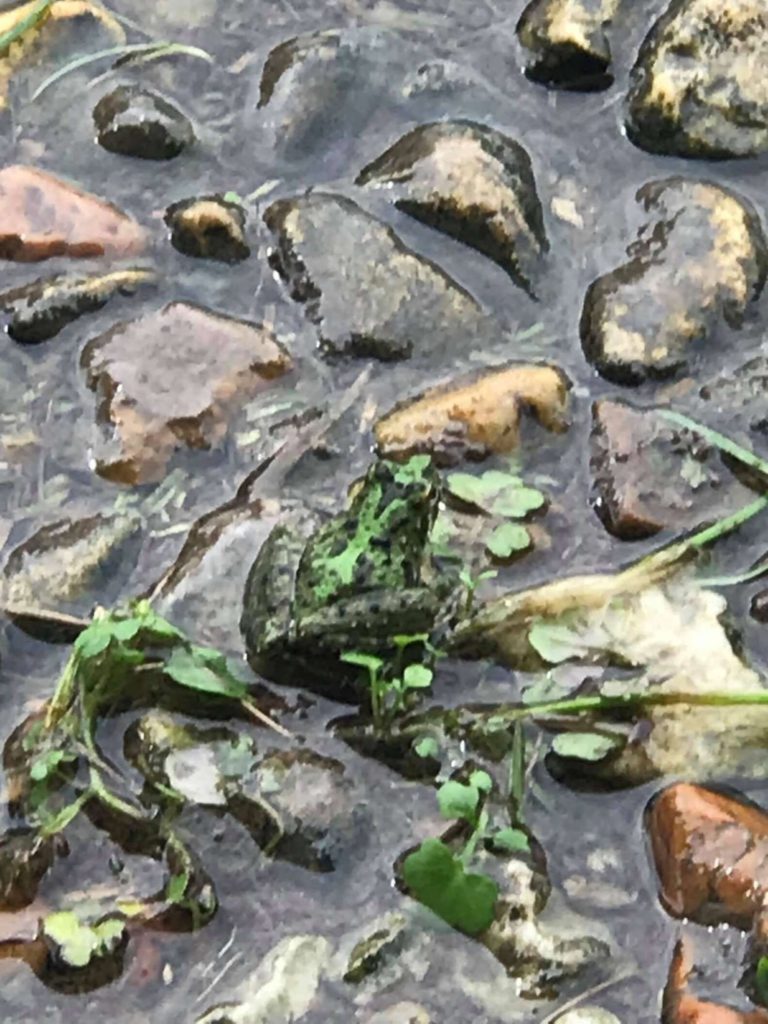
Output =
[{"x1": 0, "y1": 165, "x2": 146, "y2": 263}]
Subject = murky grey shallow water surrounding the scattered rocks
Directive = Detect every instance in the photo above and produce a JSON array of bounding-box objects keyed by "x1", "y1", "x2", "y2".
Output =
[{"x1": 0, "y1": 0, "x2": 768, "y2": 1024}]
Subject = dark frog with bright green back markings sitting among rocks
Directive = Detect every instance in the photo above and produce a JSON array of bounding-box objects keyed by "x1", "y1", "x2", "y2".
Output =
[{"x1": 241, "y1": 455, "x2": 454, "y2": 688}]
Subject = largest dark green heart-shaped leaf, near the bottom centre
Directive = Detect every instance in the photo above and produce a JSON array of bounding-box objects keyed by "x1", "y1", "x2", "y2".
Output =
[{"x1": 402, "y1": 839, "x2": 499, "y2": 935}]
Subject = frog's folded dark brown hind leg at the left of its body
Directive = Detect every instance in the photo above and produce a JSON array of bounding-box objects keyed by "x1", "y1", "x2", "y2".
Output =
[{"x1": 240, "y1": 526, "x2": 306, "y2": 671}]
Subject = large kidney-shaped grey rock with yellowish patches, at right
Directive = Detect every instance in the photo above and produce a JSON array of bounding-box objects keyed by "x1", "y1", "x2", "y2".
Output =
[{"x1": 581, "y1": 178, "x2": 768, "y2": 384}]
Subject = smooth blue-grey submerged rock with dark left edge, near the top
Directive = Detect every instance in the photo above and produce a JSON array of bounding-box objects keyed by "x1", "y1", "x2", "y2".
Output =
[{"x1": 259, "y1": 29, "x2": 392, "y2": 160}]
